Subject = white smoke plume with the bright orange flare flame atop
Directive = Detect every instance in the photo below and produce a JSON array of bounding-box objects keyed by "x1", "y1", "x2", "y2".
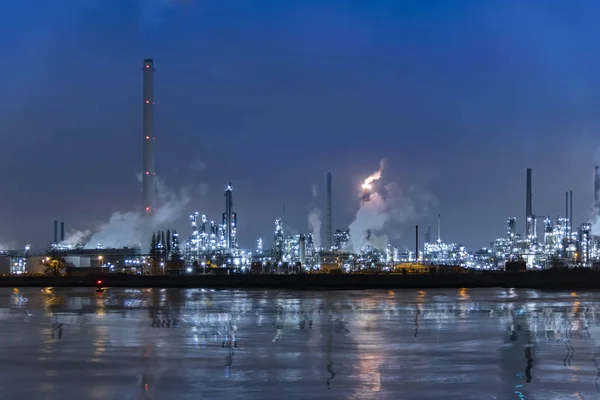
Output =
[{"x1": 348, "y1": 161, "x2": 435, "y2": 253}]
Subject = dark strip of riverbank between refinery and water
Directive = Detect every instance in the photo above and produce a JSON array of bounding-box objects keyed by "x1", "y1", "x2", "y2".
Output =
[{"x1": 0, "y1": 269, "x2": 600, "y2": 290}]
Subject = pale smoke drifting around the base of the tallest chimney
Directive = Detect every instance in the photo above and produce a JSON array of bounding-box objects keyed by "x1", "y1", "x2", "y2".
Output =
[{"x1": 61, "y1": 177, "x2": 192, "y2": 249}]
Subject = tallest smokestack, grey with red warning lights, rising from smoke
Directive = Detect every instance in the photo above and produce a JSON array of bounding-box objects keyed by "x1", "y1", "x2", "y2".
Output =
[{"x1": 142, "y1": 58, "x2": 155, "y2": 215}]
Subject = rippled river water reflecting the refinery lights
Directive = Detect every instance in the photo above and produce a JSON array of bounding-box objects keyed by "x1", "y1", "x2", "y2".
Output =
[{"x1": 0, "y1": 288, "x2": 600, "y2": 400}]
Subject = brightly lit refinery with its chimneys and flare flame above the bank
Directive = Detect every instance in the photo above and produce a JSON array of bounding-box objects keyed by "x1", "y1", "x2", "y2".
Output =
[{"x1": 8, "y1": 58, "x2": 600, "y2": 274}]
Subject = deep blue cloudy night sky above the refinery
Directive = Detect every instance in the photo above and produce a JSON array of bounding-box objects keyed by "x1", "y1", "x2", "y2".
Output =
[{"x1": 0, "y1": 0, "x2": 600, "y2": 250}]
